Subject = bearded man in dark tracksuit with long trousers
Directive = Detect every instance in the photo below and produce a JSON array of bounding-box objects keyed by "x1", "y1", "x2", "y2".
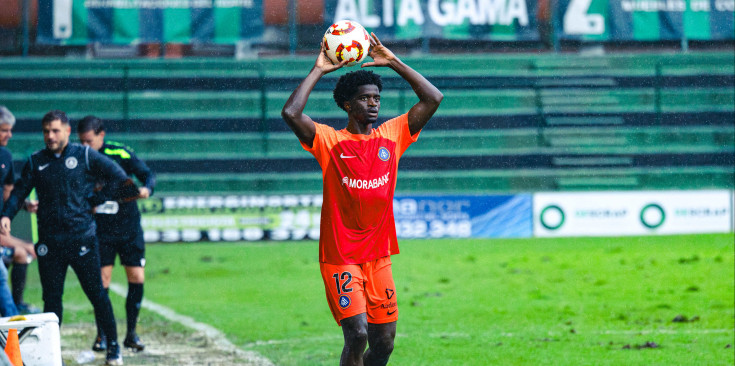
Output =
[{"x1": 0, "y1": 110, "x2": 138, "y2": 365}]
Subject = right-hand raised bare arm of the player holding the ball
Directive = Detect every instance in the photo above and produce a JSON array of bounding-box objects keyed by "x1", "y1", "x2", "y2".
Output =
[{"x1": 362, "y1": 33, "x2": 444, "y2": 135}]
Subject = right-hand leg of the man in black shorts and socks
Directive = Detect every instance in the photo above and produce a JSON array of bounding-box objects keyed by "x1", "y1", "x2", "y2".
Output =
[{"x1": 118, "y1": 229, "x2": 145, "y2": 352}]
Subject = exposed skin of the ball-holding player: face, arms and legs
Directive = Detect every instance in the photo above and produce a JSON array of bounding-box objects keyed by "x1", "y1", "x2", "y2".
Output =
[{"x1": 281, "y1": 33, "x2": 444, "y2": 366}]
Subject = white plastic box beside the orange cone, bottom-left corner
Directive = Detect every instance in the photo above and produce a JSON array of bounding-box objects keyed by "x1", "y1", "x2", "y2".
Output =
[{"x1": 0, "y1": 313, "x2": 62, "y2": 366}]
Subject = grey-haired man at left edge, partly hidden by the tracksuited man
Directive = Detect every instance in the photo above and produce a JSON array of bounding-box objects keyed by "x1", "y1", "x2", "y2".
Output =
[{"x1": 0, "y1": 106, "x2": 40, "y2": 314}]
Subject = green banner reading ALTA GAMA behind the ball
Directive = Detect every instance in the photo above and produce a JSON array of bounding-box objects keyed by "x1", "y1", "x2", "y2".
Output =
[{"x1": 324, "y1": 0, "x2": 539, "y2": 41}]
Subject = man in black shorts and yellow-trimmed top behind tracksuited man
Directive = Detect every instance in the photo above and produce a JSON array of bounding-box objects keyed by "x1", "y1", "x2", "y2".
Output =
[{"x1": 77, "y1": 116, "x2": 156, "y2": 352}]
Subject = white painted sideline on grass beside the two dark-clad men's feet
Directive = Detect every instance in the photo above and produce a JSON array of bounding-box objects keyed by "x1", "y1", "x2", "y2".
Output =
[{"x1": 110, "y1": 283, "x2": 274, "y2": 366}]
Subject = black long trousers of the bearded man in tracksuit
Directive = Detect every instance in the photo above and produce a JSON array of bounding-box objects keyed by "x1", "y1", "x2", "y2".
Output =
[{"x1": 36, "y1": 235, "x2": 117, "y2": 341}]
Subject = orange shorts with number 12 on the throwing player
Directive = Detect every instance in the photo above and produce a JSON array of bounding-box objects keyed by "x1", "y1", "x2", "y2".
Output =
[{"x1": 320, "y1": 257, "x2": 398, "y2": 325}]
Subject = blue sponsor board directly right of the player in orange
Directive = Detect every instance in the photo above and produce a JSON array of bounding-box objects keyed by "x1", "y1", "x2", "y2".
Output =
[{"x1": 393, "y1": 194, "x2": 533, "y2": 238}]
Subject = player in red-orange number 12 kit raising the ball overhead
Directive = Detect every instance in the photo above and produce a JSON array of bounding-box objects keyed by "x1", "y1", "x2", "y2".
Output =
[{"x1": 281, "y1": 34, "x2": 444, "y2": 365}]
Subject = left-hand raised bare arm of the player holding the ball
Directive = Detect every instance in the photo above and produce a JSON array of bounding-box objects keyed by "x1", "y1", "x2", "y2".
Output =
[{"x1": 281, "y1": 43, "x2": 347, "y2": 147}]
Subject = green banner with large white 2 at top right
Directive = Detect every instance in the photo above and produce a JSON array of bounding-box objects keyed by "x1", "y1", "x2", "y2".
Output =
[{"x1": 554, "y1": 0, "x2": 735, "y2": 41}]
